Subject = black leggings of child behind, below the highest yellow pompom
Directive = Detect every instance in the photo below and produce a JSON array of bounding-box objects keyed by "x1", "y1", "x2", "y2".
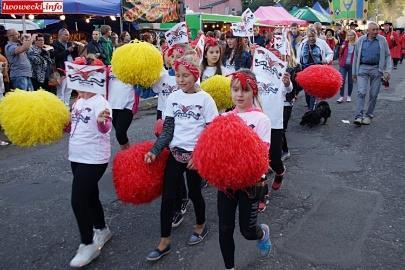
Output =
[{"x1": 112, "y1": 109, "x2": 134, "y2": 145}]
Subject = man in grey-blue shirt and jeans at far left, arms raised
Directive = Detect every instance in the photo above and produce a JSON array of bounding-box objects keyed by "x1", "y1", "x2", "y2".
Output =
[{"x1": 5, "y1": 29, "x2": 33, "y2": 90}]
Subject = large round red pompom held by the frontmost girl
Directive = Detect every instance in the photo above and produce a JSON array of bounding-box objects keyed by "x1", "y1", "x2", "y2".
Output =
[{"x1": 193, "y1": 114, "x2": 269, "y2": 190}]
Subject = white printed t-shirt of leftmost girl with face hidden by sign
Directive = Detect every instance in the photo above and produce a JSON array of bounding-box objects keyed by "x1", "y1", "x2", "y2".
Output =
[{"x1": 69, "y1": 95, "x2": 112, "y2": 164}]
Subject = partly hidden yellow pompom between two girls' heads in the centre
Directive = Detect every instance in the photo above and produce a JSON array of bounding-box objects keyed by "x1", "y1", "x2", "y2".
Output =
[{"x1": 201, "y1": 75, "x2": 233, "y2": 111}]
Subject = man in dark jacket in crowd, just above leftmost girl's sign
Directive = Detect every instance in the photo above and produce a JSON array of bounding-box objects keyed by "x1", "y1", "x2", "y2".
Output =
[{"x1": 53, "y1": 28, "x2": 78, "y2": 75}]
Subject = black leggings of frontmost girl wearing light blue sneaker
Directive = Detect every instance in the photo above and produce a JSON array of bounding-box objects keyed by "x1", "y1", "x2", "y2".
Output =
[{"x1": 217, "y1": 190, "x2": 263, "y2": 269}]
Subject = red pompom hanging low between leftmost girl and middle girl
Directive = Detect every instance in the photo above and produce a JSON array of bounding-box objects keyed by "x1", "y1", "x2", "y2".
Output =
[{"x1": 113, "y1": 141, "x2": 169, "y2": 204}]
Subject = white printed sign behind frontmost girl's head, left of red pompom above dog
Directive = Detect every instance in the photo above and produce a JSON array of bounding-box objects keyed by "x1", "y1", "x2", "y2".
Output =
[{"x1": 252, "y1": 47, "x2": 287, "y2": 94}]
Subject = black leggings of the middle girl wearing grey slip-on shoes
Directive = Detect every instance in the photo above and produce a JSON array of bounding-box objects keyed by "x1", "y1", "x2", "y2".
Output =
[{"x1": 160, "y1": 153, "x2": 205, "y2": 237}]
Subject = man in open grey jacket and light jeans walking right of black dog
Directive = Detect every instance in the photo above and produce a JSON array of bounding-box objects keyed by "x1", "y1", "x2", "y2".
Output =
[{"x1": 353, "y1": 22, "x2": 392, "y2": 125}]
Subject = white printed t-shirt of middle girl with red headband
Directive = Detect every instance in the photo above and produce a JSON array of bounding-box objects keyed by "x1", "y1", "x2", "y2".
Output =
[{"x1": 163, "y1": 90, "x2": 218, "y2": 151}]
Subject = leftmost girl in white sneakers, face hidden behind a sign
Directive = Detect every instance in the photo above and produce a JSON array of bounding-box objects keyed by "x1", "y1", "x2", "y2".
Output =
[{"x1": 66, "y1": 57, "x2": 112, "y2": 267}]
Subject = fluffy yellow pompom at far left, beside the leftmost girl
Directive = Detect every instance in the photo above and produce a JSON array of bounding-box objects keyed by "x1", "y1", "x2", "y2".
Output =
[{"x1": 0, "y1": 90, "x2": 70, "y2": 147}]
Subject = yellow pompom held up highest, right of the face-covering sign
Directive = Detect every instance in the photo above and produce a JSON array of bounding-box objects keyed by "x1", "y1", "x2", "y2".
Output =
[{"x1": 111, "y1": 41, "x2": 163, "y2": 88}]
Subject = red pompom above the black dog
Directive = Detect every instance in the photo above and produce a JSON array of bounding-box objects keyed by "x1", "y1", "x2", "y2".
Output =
[{"x1": 296, "y1": 65, "x2": 343, "y2": 99}]
